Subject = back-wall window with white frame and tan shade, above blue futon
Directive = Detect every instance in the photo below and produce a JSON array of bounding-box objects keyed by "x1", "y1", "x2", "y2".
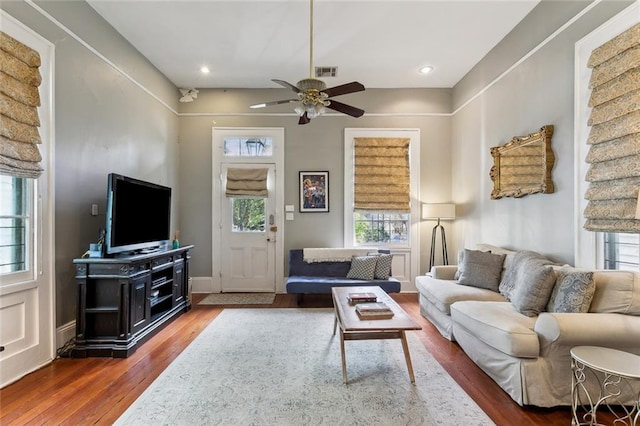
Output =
[{"x1": 344, "y1": 129, "x2": 420, "y2": 250}]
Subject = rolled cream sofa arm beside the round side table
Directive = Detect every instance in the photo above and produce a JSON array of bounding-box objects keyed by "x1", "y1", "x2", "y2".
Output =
[{"x1": 534, "y1": 312, "x2": 640, "y2": 348}]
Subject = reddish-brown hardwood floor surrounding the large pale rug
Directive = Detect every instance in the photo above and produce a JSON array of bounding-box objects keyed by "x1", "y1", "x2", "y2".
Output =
[{"x1": 0, "y1": 294, "x2": 571, "y2": 426}]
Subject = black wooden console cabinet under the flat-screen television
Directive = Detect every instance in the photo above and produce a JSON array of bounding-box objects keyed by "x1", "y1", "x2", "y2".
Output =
[{"x1": 71, "y1": 246, "x2": 193, "y2": 358}]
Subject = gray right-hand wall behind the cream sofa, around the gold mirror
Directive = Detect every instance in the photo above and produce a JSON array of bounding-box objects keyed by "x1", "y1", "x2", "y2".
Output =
[{"x1": 451, "y1": 1, "x2": 632, "y2": 264}]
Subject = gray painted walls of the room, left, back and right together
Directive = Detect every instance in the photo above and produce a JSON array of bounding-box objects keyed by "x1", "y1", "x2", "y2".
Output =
[{"x1": 0, "y1": 0, "x2": 631, "y2": 326}]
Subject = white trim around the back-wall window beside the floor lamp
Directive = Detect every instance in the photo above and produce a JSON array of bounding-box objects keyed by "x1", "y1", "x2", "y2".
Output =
[{"x1": 343, "y1": 128, "x2": 420, "y2": 282}]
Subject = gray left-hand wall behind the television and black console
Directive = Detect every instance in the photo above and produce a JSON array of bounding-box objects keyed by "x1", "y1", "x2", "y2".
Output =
[{"x1": 0, "y1": 1, "x2": 180, "y2": 326}]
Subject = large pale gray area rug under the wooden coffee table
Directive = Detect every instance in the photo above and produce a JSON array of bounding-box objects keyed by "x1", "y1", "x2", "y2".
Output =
[{"x1": 116, "y1": 308, "x2": 494, "y2": 426}]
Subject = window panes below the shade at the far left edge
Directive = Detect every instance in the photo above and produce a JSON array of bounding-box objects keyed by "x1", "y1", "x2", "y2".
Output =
[{"x1": 0, "y1": 175, "x2": 33, "y2": 281}]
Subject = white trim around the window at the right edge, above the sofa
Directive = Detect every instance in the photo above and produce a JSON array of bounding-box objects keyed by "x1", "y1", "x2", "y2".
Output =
[{"x1": 574, "y1": 2, "x2": 640, "y2": 268}]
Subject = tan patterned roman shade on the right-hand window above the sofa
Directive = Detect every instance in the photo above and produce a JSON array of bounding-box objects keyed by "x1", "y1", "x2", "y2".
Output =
[{"x1": 584, "y1": 24, "x2": 640, "y2": 233}]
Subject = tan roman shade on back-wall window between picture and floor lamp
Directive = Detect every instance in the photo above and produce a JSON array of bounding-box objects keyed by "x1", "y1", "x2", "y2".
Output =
[{"x1": 354, "y1": 138, "x2": 410, "y2": 212}]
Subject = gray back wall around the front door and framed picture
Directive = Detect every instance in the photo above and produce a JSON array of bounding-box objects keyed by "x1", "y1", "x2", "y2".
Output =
[{"x1": 180, "y1": 88, "x2": 451, "y2": 277}]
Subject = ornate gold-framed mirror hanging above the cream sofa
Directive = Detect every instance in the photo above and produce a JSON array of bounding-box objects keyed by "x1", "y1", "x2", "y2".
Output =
[{"x1": 489, "y1": 125, "x2": 555, "y2": 200}]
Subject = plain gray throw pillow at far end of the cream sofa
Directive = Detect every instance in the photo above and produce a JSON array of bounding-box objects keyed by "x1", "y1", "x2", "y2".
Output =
[{"x1": 458, "y1": 249, "x2": 505, "y2": 291}]
